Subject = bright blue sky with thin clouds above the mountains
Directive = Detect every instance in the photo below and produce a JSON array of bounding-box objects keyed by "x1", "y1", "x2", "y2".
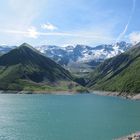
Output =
[{"x1": 0, "y1": 0, "x2": 140, "y2": 46}]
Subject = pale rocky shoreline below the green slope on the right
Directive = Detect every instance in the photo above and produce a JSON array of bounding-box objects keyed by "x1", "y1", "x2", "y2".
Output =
[{"x1": 90, "y1": 90, "x2": 140, "y2": 100}]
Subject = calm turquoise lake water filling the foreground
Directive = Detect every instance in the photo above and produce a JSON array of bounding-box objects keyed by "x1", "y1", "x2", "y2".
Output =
[{"x1": 0, "y1": 94, "x2": 140, "y2": 140}]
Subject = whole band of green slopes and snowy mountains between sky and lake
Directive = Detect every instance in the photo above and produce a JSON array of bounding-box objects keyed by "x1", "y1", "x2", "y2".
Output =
[{"x1": 0, "y1": 42, "x2": 140, "y2": 96}]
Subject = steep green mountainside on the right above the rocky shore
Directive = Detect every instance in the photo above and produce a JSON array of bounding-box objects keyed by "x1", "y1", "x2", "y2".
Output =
[{"x1": 87, "y1": 43, "x2": 140, "y2": 94}]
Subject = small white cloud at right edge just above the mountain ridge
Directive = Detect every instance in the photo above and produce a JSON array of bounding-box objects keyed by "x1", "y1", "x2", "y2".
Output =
[{"x1": 129, "y1": 32, "x2": 140, "y2": 44}]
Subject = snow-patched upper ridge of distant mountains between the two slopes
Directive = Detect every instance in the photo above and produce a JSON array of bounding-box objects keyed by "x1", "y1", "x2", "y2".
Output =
[{"x1": 36, "y1": 41, "x2": 131, "y2": 65}]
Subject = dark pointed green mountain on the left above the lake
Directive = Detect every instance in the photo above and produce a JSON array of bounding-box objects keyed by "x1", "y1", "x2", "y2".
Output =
[{"x1": 0, "y1": 43, "x2": 85, "y2": 91}]
